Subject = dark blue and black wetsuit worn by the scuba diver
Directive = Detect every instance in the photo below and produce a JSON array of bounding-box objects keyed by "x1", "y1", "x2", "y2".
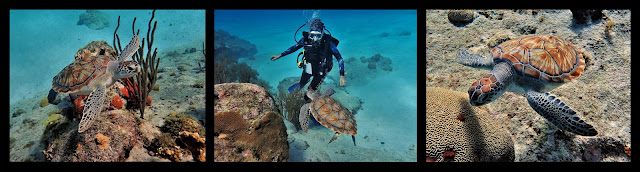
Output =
[{"x1": 280, "y1": 32, "x2": 344, "y2": 91}]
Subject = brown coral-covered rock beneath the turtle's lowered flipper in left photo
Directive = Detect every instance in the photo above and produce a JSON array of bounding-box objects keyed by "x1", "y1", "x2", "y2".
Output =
[{"x1": 41, "y1": 110, "x2": 141, "y2": 162}]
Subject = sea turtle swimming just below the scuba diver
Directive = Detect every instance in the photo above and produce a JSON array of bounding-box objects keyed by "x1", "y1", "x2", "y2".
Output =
[{"x1": 299, "y1": 89, "x2": 358, "y2": 146}]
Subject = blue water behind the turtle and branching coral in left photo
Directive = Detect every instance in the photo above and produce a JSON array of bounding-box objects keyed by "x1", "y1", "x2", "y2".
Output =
[{"x1": 9, "y1": 10, "x2": 206, "y2": 104}]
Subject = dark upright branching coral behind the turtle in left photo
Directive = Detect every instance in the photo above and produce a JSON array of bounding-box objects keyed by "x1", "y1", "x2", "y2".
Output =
[{"x1": 113, "y1": 10, "x2": 160, "y2": 119}]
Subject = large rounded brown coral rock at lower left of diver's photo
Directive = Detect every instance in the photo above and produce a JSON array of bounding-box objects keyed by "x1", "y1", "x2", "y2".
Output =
[{"x1": 213, "y1": 83, "x2": 289, "y2": 162}]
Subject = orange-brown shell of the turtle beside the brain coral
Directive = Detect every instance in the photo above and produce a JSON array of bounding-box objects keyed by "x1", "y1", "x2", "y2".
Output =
[{"x1": 491, "y1": 35, "x2": 585, "y2": 83}]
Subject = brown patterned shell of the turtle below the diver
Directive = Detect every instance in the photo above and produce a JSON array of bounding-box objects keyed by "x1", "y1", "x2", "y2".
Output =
[{"x1": 309, "y1": 95, "x2": 358, "y2": 135}]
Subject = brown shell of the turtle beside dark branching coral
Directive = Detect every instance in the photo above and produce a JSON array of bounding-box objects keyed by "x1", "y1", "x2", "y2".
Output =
[{"x1": 52, "y1": 56, "x2": 115, "y2": 93}]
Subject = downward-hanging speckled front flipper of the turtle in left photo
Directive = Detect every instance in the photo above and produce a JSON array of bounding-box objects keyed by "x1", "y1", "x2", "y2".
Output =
[{"x1": 78, "y1": 85, "x2": 107, "y2": 133}]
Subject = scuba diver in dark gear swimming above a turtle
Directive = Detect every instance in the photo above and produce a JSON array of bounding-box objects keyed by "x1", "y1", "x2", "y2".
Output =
[{"x1": 271, "y1": 19, "x2": 347, "y2": 99}]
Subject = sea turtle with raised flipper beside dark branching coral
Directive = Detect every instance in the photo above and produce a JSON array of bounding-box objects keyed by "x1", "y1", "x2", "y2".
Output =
[{"x1": 49, "y1": 35, "x2": 140, "y2": 133}]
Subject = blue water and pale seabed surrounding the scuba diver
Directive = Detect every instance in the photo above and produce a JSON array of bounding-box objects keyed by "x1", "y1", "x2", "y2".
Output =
[{"x1": 214, "y1": 10, "x2": 418, "y2": 161}]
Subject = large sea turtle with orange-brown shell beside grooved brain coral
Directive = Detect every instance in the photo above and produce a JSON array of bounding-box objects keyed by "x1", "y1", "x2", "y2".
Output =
[{"x1": 457, "y1": 35, "x2": 598, "y2": 136}]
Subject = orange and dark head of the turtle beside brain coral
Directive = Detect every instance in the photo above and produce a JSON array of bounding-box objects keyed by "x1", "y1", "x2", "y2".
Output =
[{"x1": 469, "y1": 73, "x2": 506, "y2": 106}]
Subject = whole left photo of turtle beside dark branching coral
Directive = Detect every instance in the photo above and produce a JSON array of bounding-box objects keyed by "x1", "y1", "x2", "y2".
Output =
[{"x1": 9, "y1": 9, "x2": 206, "y2": 162}]
